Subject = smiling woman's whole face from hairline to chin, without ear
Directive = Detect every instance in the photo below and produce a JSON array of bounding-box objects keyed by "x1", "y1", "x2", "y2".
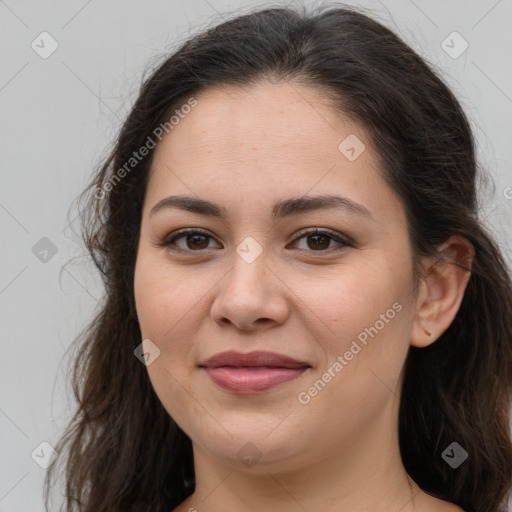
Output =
[{"x1": 135, "y1": 82, "x2": 420, "y2": 471}]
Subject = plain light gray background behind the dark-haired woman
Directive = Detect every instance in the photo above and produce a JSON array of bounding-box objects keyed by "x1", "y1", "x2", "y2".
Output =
[{"x1": 0, "y1": 0, "x2": 512, "y2": 512}]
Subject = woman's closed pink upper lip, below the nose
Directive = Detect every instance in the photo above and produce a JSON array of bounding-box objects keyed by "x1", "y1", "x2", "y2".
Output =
[{"x1": 199, "y1": 350, "x2": 310, "y2": 368}]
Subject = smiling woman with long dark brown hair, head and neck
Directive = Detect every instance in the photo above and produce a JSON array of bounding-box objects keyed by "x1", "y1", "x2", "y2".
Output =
[{"x1": 46, "y1": 7, "x2": 512, "y2": 512}]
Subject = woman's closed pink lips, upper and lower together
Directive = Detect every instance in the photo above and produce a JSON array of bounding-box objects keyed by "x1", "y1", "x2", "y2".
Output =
[{"x1": 199, "y1": 351, "x2": 311, "y2": 395}]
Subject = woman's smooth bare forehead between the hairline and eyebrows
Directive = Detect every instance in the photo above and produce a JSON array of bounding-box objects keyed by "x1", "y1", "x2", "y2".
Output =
[{"x1": 147, "y1": 82, "x2": 403, "y2": 228}]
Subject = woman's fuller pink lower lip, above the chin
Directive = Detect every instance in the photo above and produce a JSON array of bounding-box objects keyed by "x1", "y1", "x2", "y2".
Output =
[{"x1": 205, "y1": 366, "x2": 307, "y2": 395}]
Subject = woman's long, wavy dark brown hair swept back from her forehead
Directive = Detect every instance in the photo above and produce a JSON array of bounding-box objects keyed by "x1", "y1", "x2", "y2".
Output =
[{"x1": 45, "y1": 6, "x2": 512, "y2": 512}]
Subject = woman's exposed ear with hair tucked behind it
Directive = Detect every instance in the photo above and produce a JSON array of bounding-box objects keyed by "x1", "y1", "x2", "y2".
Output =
[{"x1": 411, "y1": 235, "x2": 475, "y2": 348}]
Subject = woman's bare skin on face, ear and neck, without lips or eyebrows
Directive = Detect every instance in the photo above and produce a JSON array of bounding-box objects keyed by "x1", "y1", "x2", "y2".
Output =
[{"x1": 134, "y1": 82, "x2": 472, "y2": 512}]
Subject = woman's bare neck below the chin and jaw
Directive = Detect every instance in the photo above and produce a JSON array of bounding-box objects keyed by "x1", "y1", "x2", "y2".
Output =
[{"x1": 178, "y1": 397, "x2": 423, "y2": 512}]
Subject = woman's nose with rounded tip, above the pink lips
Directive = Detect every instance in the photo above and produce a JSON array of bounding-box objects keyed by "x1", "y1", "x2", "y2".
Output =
[{"x1": 211, "y1": 254, "x2": 290, "y2": 331}]
